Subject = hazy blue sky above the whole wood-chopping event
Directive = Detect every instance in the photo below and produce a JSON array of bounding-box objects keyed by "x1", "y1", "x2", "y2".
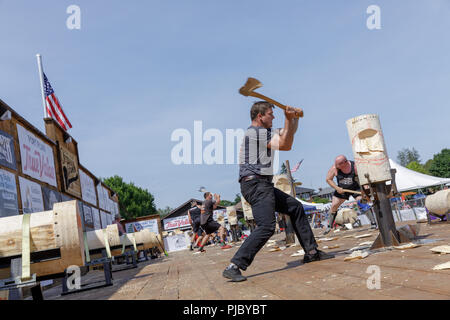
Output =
[{"x1": 0, "y1": 0, "x2": 450, "y2": 207}]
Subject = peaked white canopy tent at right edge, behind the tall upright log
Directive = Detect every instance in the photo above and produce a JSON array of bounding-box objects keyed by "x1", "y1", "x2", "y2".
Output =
[{"x1": 389, "y1": 159, "x2": 450, "y2": 192}]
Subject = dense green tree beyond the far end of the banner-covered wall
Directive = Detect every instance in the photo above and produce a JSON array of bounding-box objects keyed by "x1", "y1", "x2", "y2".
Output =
[{"x1": 102, "y1": 175, "x2": 156, "y2": 219}]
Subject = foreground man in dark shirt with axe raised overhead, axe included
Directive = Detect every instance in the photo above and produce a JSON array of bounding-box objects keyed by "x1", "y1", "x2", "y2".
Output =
[{"x1": 223, "y1": 78, "x2": 334, "y2": 282}]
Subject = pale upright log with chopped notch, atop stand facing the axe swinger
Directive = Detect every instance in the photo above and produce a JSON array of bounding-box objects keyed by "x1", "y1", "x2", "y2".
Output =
[{"x1": 346, "y1": 114, "x2": 392, "y2": 185}]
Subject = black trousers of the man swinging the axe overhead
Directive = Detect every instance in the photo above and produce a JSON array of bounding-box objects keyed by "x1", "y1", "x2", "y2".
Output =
[{"x1": 231, "y1": 179, "x2": 317, "y2": 270}]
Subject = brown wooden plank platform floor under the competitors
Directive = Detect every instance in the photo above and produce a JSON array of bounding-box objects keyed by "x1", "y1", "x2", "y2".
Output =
[{"x1": 39, "y1": 222, "x2": 450, "y2": 300}]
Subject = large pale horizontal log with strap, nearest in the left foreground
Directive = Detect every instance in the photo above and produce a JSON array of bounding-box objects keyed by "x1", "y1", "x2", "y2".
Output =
[{"x1": 0, "y1": 201, "x2": 85, "y2": 279}]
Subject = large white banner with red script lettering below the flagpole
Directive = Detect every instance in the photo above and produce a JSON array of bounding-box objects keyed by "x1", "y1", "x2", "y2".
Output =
[{"x1": 17, "y1": 124, "x2": 57, "y2": 187}]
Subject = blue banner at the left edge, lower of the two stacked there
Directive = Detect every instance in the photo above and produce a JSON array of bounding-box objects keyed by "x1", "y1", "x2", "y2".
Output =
[{"x1": 0, "y1": 169, "x2": 19, "y2": 217}]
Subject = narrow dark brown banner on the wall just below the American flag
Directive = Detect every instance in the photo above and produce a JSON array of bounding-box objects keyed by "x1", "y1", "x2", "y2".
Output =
[{"x1": 59, "y1": 146, "x2": 81, "y2": 198}]
